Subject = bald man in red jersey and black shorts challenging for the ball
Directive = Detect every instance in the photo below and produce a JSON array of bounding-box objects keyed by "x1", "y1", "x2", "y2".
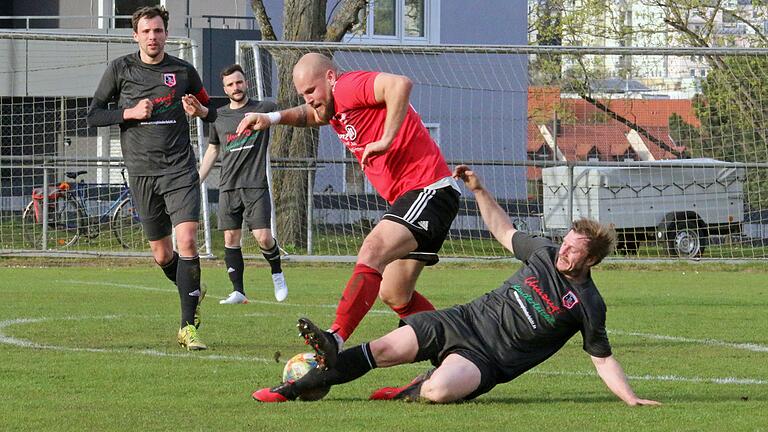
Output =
[{"x1": 237, "y1": 53, "x2": 460, "y2": 367}]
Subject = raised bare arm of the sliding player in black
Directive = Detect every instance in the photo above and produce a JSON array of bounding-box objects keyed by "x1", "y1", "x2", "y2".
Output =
[{"x1": 453, "y1": 165, "x2": 517, "y2": 253}]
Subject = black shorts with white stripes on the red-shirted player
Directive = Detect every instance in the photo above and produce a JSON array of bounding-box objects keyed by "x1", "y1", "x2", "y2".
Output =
[{"x1": 383, "y1": 186, "x2": 460, "y2": 265}]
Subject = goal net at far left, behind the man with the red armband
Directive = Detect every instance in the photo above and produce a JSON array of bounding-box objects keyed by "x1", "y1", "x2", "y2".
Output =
[{"x1": 0, "y1": 32, "x2": 210, "y2": 255}]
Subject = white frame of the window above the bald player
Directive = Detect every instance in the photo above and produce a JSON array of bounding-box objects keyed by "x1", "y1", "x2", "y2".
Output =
[{"x1": 344, "y1": 0, "x2": 440, "y2": 45}]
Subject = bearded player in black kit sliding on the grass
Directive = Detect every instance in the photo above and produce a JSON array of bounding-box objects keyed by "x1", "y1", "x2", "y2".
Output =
[{"x1": 253, "y1": 165, "x2": 659, "y2": 406}]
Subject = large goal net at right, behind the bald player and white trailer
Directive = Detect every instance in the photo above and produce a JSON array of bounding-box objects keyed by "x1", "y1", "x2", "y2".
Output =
[{"x1": 238, "y1": 41, "x2": 768, "y2": 259}]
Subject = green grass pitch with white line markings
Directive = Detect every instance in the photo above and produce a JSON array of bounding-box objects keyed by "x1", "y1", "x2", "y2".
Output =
[{"x1": 0, "y1": 259, "x2": 768, "y2": 432}]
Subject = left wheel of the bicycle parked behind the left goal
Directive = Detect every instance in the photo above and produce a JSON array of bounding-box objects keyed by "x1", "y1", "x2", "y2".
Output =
[{"x1": 22, "y1": 198, "x2": 85, "y2": 249}]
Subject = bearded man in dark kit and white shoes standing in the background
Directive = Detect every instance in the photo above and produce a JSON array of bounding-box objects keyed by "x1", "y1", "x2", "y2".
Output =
[{"x1": 199, "y1": 64, "x2": 288, "y2": 304}]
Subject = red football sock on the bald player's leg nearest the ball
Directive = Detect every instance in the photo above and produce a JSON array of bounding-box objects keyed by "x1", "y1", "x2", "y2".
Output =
[{"x1": 331, "y1": 264, "x2": 382, "y2": 340}]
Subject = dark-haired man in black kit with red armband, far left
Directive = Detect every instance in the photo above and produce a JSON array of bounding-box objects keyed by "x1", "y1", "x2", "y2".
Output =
[{"x1": 87, "y1": 6, "x2": 216, "y2": 350}]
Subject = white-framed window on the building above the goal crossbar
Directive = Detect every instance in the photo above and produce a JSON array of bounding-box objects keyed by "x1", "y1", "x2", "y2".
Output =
[{"x1": 346, "y1": 0, "x2": 440, "y2": 43}]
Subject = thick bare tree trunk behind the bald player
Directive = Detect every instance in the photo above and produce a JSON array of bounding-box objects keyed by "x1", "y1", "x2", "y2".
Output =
[{"x1": 246, "y1": 0, "x2": 367, "y2": 247}]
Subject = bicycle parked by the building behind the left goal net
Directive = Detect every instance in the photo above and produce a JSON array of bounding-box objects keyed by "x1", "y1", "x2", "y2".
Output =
[{"x1": 22, "y1": 169, "x2": 147, "y2": 249}]
